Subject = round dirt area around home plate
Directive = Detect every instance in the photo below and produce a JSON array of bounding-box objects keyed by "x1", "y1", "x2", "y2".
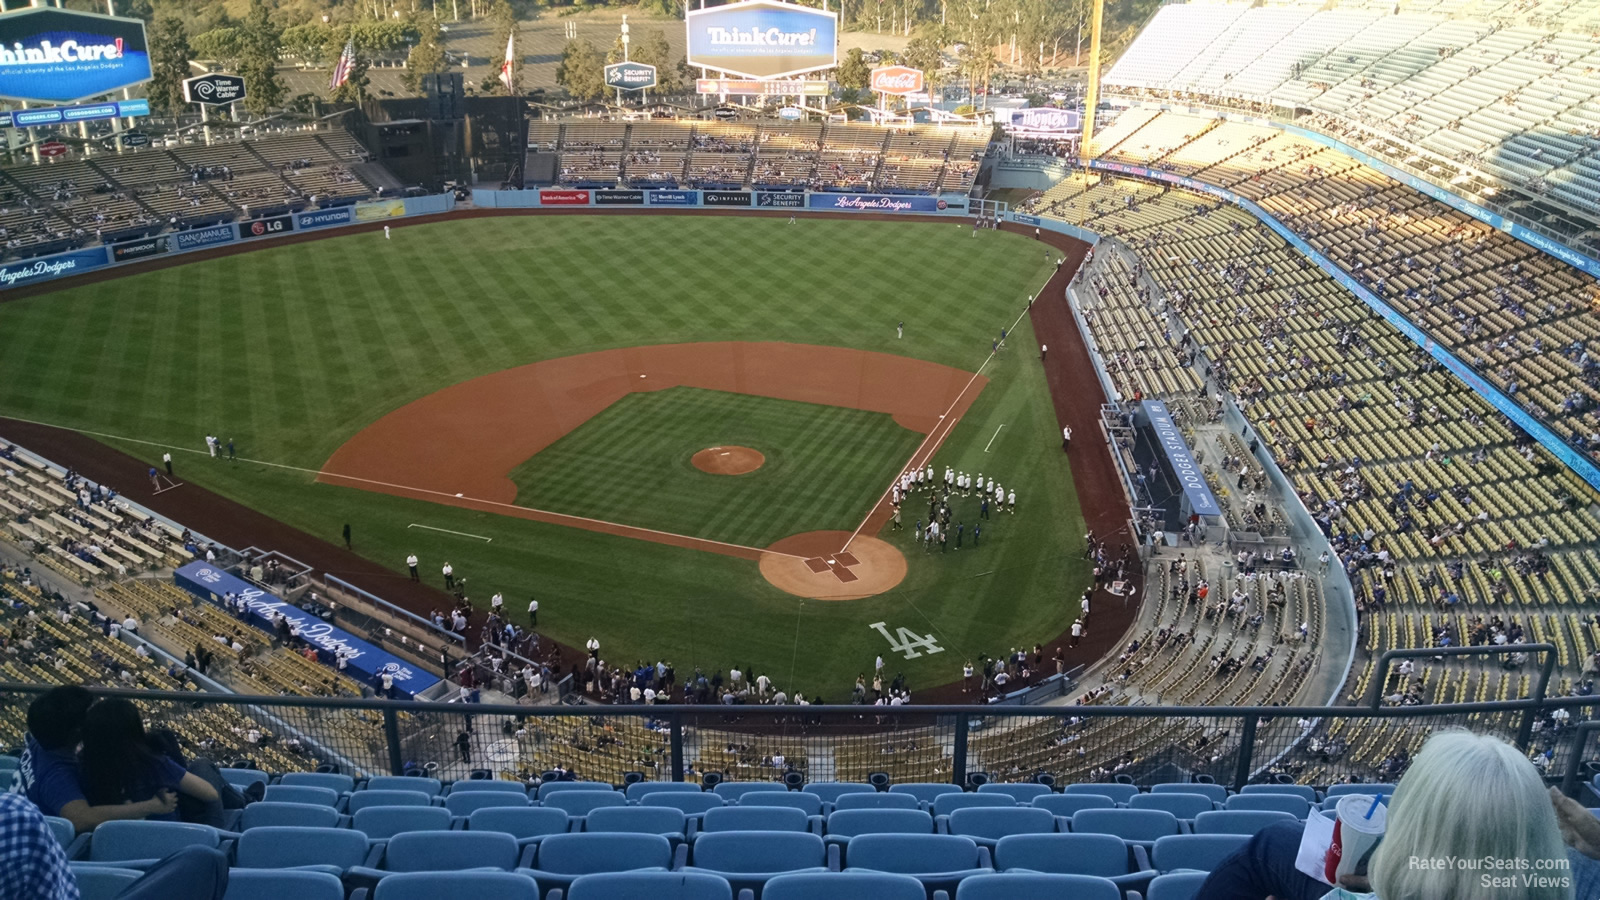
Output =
[{"x1": 762, "y1": 532, "x2": 906, "y2": 601}]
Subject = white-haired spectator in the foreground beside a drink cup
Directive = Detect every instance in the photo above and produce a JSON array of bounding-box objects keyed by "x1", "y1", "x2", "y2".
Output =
[{"x1": 1195, "y1": 730, "x2": 1597, "y2": 900}]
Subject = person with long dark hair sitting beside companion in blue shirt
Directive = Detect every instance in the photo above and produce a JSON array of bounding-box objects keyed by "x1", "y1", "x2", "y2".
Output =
[{"x1": 78, "y1": 697, "x2": 221, "y2": 820}]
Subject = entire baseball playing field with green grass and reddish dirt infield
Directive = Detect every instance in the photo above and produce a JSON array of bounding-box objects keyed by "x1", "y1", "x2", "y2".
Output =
[{"x1": 0, "y1": 216, "x2": 1099, "y2": 701}]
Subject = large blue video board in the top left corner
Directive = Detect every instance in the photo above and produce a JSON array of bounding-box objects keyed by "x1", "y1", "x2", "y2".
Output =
[{"x1": 0, "y1": 6, "x2": 150, "y2": 102}]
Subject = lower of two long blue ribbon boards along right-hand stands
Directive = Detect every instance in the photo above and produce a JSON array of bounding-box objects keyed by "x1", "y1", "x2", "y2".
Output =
[{"x1": 1075, "y1": 153, "x2": 1600, "y2": 490}]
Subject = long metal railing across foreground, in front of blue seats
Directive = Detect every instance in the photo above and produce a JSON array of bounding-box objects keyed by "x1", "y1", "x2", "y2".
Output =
[{"x1": 0, "y1": 684, "x2": 1600, "y2": 790}]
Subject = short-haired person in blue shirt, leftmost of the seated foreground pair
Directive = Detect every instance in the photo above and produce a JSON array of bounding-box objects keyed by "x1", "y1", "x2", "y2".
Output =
[{"x1": 21, "y1": 685, "x2": 178, "y2": 831}]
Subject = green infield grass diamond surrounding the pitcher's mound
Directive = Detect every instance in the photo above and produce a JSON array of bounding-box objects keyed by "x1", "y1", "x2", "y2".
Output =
[{"x1": 512, "y1": 388, "x2": 923, "y2": 548}]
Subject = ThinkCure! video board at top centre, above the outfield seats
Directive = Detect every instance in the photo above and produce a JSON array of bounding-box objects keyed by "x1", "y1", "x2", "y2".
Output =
[{"x1": 688, "y1": 0, "x2": 838, "y2": 78}]
